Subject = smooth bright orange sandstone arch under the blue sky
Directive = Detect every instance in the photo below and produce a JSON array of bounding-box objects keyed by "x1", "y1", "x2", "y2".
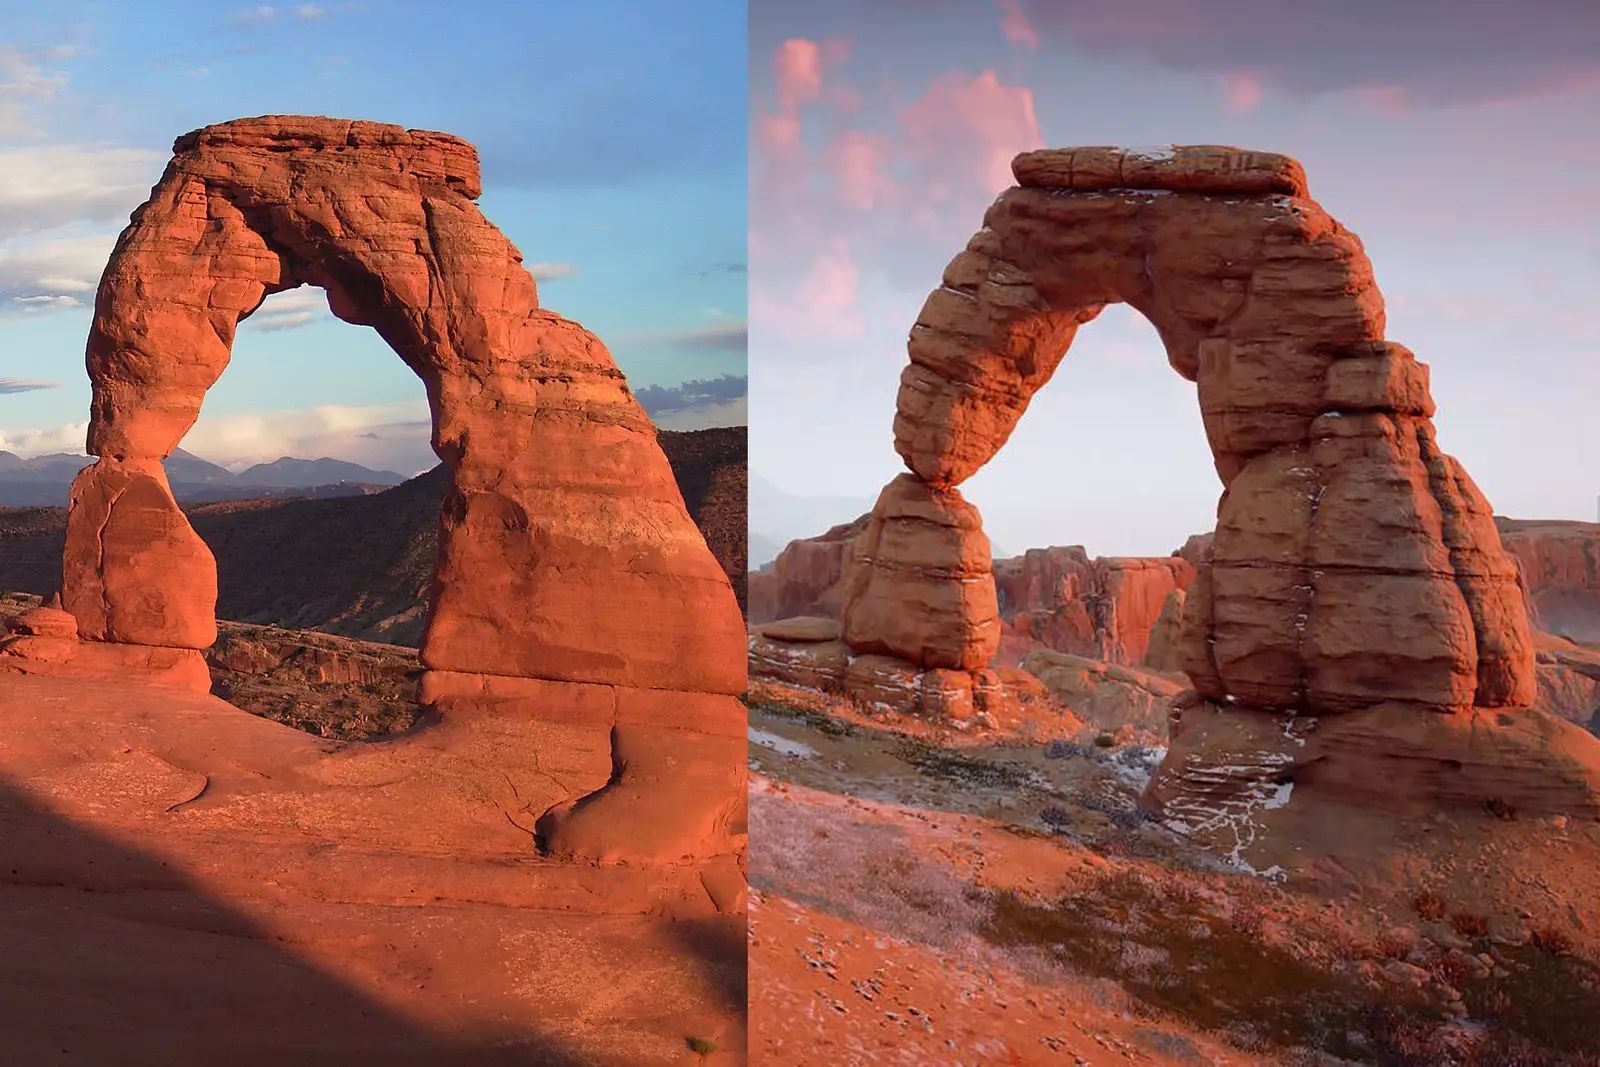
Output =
[{"x1": 53, "y1": 115, "x2": 746, "y2": 857}]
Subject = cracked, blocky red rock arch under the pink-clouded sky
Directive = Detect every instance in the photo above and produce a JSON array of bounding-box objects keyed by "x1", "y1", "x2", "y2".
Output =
[{"x1": 843, "y1": 147, "x2": 1534, "y2": 713}]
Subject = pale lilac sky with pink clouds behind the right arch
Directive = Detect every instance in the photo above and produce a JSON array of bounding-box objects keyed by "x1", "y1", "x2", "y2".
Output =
[{"x1": 749, "y1": 0, "x2": 1600, "y2": 555}]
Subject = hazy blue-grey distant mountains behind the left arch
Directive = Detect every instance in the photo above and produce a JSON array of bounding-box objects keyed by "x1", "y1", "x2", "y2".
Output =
[{"x1": 0, "y1": 448, "x2": 405, "y2": 507}]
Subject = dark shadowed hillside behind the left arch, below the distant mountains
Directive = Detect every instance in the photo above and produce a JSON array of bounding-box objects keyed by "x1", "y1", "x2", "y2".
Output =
[{"x1": 0, "y1": 427, "x2": 746, "y2": 646}]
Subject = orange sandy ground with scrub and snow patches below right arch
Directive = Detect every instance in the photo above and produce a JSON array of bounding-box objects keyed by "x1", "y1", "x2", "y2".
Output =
[{"x1": 749, "y1": 685, "x2": 1600, "y2": 1067}]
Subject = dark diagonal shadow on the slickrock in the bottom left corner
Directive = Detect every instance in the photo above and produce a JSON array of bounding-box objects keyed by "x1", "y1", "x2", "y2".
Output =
[{"x1": 0, "y1": 784, "x2": 624, "y2": 1067}]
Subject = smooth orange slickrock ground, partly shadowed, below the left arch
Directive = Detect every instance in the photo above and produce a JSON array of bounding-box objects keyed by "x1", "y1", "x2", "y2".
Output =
[{"x1": 0, "y1": 671, "x2": 746, "y2": 1067}]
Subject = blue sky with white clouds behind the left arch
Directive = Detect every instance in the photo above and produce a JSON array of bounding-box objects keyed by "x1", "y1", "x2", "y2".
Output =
[{"x1": 0, "y1": 0, "x2": 747, "y2": 474}]
